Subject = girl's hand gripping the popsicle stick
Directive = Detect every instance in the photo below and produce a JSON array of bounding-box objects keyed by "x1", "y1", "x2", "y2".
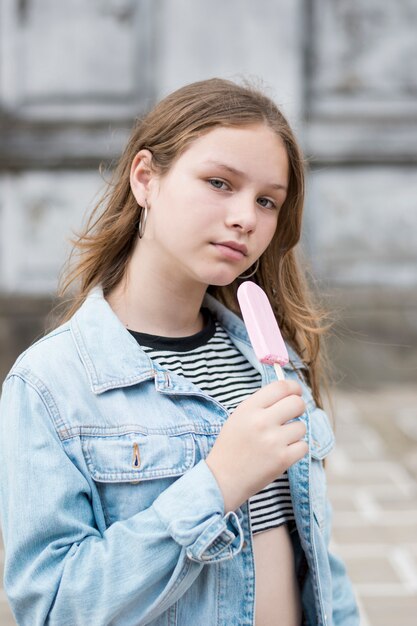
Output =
[{"x1": 206, "y1": 381, "x2": 308, "y2": 512}]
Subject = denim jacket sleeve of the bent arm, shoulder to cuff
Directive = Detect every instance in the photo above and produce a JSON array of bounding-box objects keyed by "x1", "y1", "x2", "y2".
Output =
[{"x1": 0, "y1": 374, "x2": 243, "y2": 626}]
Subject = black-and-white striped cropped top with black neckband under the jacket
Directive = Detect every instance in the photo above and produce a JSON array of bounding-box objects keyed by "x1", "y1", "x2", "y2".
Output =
[{"x1": 129, "y1": 308, "x2": 294, "y2": 533}]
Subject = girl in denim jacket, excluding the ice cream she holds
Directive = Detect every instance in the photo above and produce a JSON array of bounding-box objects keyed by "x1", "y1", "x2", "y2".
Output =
[{"x1": 0, "y1": 79, "x2": 359, "y2": 626}]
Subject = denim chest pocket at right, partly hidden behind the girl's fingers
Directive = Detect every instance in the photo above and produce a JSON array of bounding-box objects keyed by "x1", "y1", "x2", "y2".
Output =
[{"x1": 308, "y1": 403, "x2": 335, "y2": 530}]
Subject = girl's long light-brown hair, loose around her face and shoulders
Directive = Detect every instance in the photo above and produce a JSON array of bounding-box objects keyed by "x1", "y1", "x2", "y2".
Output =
[{"x1": 58, "y1": 78, "x2": 327, "y2": 405}]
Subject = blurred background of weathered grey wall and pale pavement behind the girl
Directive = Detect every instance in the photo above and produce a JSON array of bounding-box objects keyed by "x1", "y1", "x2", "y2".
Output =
[{"x1": 0, "y1": 0, "x2": 417, "y2": 626}]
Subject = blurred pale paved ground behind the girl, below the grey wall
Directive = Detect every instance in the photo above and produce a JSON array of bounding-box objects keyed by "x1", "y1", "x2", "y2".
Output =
[{"x1": 0, "y1": 385, "x2": 417, "y2": 626}]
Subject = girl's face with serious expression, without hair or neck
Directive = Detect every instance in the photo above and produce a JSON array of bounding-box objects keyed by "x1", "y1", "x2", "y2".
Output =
[{"x1": 138, "y1": 124, "x2": 289, "y2": 286}]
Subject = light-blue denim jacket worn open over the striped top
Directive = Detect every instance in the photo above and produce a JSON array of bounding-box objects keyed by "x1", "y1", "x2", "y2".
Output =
[{"x1": 0, "y1": 288, "x2": 359, "y2": 626}]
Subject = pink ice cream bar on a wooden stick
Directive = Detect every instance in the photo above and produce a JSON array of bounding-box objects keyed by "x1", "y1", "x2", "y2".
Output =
[{"x1": 237, "y1": 280, "x2": 289, "y2": 380}]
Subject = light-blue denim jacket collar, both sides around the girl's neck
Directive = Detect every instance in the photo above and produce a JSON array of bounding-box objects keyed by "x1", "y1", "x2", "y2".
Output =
[{"x1": 69, "y1": 286, "x2": 303, "y2": 394}]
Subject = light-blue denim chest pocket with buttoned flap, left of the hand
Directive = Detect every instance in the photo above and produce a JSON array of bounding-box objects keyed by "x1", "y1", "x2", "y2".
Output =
[{"x1": 81, "y1": 429, "x2": 195, "y2": 526}]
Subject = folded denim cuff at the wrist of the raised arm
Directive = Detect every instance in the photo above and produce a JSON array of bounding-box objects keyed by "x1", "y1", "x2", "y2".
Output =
[{"x1": 152, "y1": 459, "x2": 244, "y2": 563}]
